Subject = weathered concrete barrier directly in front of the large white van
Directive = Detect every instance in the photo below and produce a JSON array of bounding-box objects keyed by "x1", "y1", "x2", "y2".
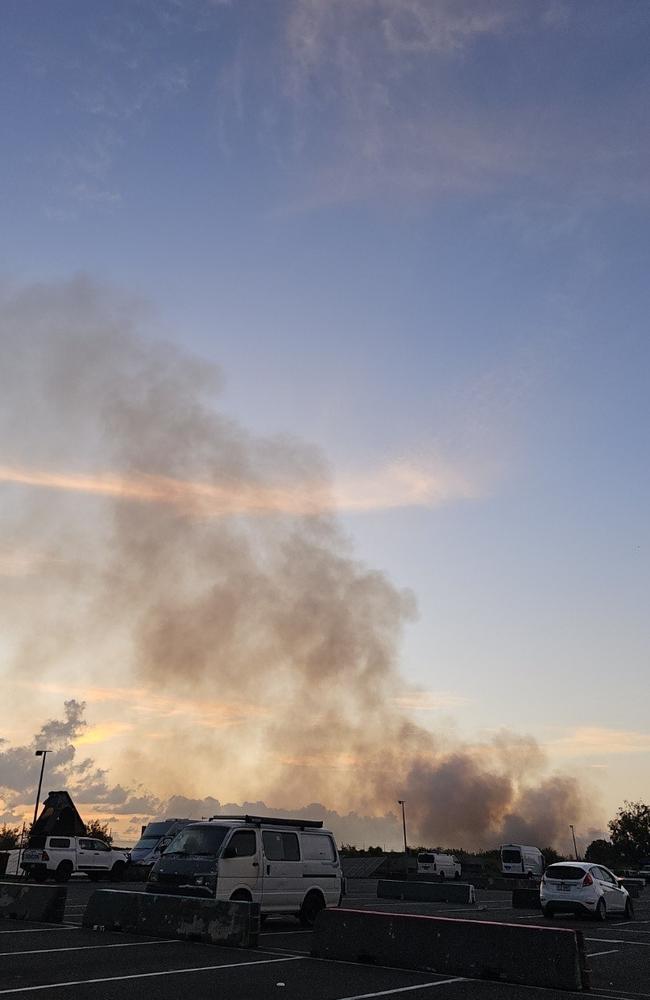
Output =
[{"x1": 83, "y1": 889, "x2": 260, "y2": 948}]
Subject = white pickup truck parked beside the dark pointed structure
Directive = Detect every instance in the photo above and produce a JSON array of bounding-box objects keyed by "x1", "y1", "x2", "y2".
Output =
[{"x1": 20, "y1": 837, "x2": 129, "y2": 882}]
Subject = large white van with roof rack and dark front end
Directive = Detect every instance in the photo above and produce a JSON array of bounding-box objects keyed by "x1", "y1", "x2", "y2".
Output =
[{"x1": 146, "y1": 816, "x2": 343, "y2": 927}]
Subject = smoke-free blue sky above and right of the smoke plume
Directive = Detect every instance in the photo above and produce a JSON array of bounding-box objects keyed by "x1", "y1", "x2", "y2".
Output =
[{"x1": 0, "y1": 0, "x2": 650, "y2": 848}]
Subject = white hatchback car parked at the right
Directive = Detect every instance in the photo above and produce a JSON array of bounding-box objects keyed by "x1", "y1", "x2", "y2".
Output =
[{"x1": 539, "y1": 861, "x2": 634, "y2": 920}]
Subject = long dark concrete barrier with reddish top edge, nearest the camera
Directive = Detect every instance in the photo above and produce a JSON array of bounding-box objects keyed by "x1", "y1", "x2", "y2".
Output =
[{"x1": 311, "y1": 909, "x2": 589, "y2": 990}]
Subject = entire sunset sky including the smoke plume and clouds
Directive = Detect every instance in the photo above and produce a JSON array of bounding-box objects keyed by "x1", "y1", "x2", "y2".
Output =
[{"x1": 0, "y1": 0, "x2": 650, "y2": 850}]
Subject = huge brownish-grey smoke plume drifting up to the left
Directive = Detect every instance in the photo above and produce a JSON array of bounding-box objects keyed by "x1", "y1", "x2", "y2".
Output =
[{"x1": 0, "y1": 278, "x2": 582, "y2": 847}]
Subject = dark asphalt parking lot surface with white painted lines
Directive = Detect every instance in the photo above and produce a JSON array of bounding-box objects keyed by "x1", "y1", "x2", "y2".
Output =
[{"x1": 0, "y1": 879, "x2": 650, "y2": 1000}]
